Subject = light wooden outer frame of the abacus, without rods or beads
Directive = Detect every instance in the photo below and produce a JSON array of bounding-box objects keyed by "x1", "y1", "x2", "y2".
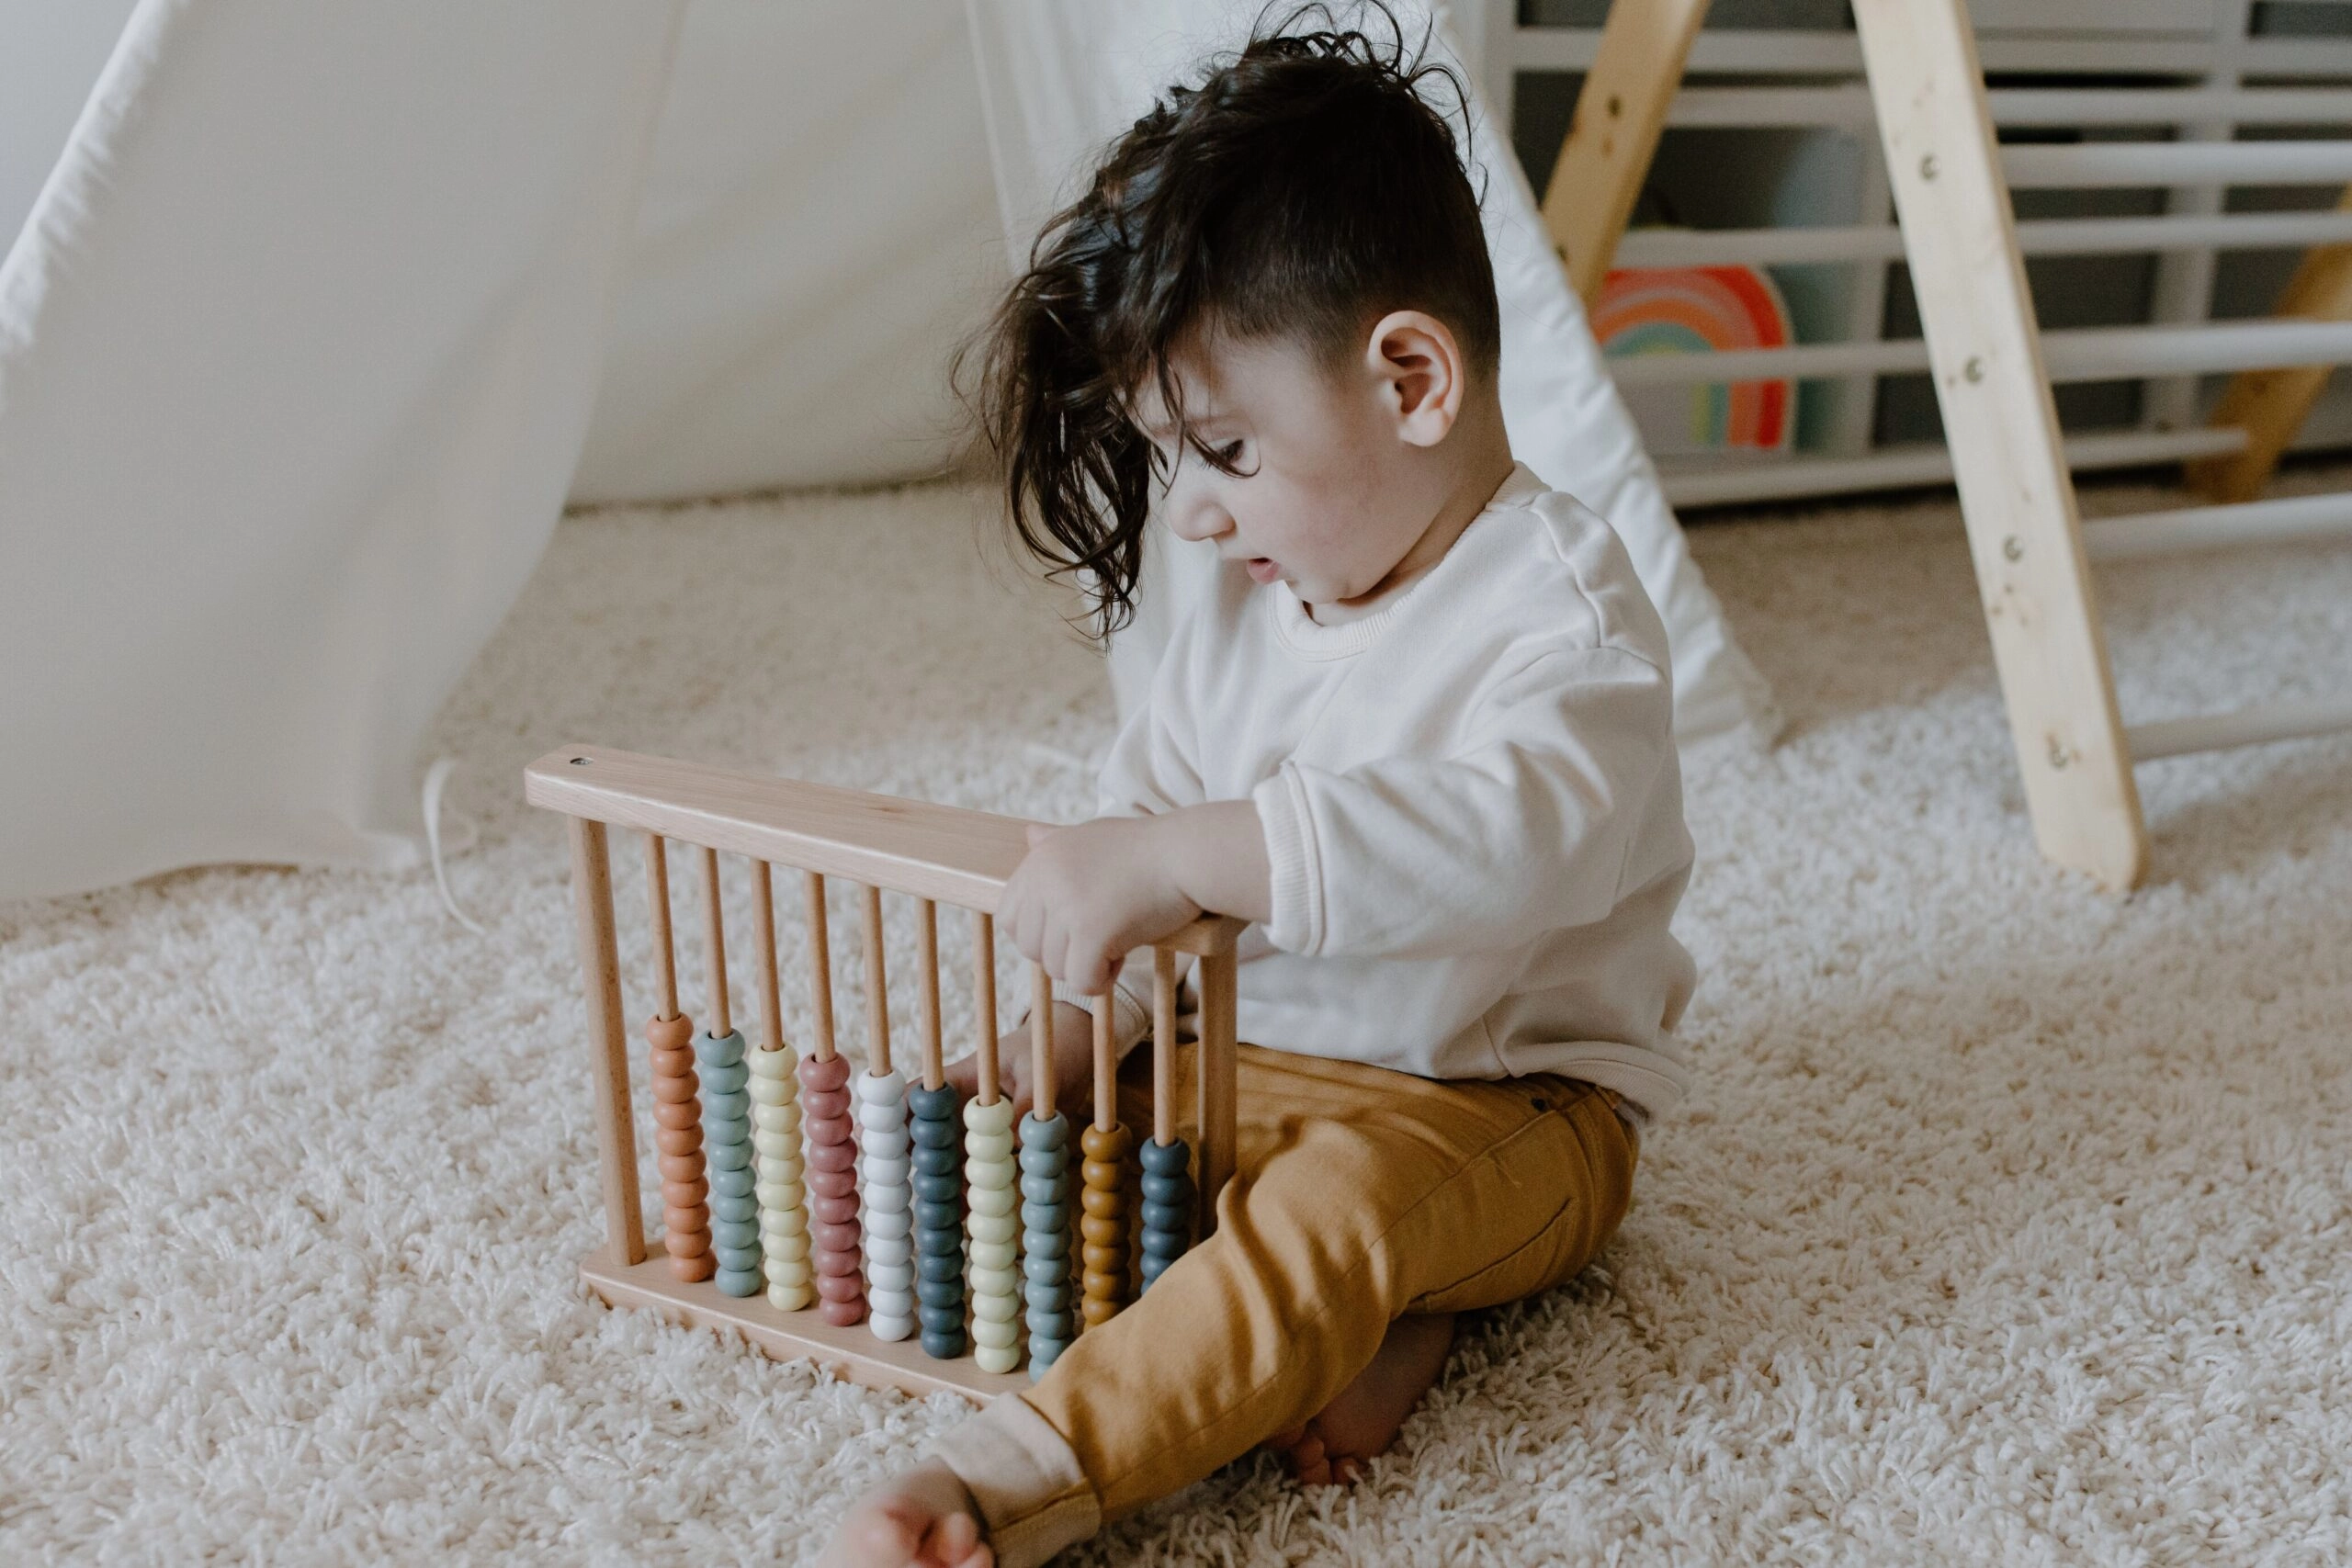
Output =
[{"x1": 522, "y1": 745, "x2": 1247, "y2": 1401}]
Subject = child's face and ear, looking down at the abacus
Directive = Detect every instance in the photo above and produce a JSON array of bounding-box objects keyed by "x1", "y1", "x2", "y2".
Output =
[{"x1": 1136, "y1": 312, "x2": 1458, "y2": 604}]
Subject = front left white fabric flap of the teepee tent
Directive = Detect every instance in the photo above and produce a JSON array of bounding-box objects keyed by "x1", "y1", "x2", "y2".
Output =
[{"x1": 0, "y1": 0, "x2": 677, "y2": 896}]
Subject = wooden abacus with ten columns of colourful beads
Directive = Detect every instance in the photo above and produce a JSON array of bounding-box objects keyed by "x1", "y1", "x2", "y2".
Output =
[{"x1": 525, "y1": 745, "x2": 1244, "y2": 1399}]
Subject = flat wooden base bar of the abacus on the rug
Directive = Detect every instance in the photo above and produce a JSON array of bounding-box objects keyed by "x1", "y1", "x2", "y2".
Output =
[{"x1": 581, "y1": 1248, "x2": 1030, "y2": 1404}]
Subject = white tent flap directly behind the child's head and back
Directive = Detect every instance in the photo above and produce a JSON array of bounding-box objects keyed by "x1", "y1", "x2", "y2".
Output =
[{"x1": 969, "y1": 0, "x2": 1778, "y2": 743}]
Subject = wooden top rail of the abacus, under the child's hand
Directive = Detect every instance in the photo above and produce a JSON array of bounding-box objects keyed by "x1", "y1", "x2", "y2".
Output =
[{"x1": 522, "y1": 745, "x2": 1247, "y2": 957}]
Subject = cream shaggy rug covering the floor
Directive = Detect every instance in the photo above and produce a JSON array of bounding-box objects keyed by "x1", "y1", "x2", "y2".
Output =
[{"x1": 0, "y1": 472, "x2": 2352, "y2": 1563}]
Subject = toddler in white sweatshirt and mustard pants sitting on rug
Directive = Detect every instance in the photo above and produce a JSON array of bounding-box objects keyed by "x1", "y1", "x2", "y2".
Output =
[{"x1": 828, "y1": 15, "x2": 1693, "y2": 1565}]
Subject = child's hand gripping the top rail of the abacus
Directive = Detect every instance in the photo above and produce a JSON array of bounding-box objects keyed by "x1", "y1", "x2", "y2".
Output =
[{"x1": 997, "y1": 816, "x2": 1200, "y2": 997}]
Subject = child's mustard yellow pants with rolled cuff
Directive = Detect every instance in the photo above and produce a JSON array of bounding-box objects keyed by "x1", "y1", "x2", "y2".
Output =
[{"x1": 933, "y1": 1043, "x2": 1637, "y2": 1568}]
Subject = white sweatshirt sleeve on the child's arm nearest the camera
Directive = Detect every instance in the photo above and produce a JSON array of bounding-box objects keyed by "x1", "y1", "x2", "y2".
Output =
[{"x1": 1251, "y1": 647, "x2": 1675, "y2": 959}]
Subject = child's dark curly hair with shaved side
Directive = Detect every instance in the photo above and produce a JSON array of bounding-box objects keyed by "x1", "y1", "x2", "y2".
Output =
[{"x1": 955, "y1": 0, "x2": 1503, "y2": 639}]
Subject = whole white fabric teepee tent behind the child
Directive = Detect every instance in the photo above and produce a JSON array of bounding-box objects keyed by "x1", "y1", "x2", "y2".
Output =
[{"x1": 0, "y1": 0, "x2": 1769, "y2": 898}]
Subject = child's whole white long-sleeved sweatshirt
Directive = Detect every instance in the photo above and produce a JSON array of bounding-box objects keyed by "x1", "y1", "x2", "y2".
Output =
[{"x1": 1099, "y1": 463, "x2": 1696, "y2": 1122}]
